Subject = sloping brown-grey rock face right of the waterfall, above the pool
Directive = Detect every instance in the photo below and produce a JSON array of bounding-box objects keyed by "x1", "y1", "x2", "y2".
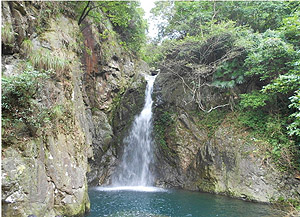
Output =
[{"x1": 154, "y1": 73, "x2": 300, "y2": 202}]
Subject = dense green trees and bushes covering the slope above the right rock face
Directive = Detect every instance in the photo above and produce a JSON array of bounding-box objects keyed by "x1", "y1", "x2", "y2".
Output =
[{"x1": 144, "y1": 1, "x2": 300, "y2": 170}]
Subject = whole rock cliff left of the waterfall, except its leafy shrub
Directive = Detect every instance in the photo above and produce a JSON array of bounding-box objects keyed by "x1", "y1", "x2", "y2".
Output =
[{"x1": 1, "y1": 2, "x2": 148, "y2": 217}]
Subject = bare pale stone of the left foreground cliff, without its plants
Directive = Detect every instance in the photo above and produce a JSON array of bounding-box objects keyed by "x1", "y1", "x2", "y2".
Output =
[{"x1": 2, "y1": 2, "x2": 92, "y2": 217}]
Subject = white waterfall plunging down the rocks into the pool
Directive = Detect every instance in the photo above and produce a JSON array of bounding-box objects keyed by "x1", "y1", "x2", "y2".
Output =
[{"x1": 112, "y1": 75, "x2": 156, "y2": 186}]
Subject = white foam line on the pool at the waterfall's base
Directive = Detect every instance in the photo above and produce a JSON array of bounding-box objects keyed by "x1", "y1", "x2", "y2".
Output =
[{"x1": 95, "y1": 186, "x2": 167, "y2": 192}]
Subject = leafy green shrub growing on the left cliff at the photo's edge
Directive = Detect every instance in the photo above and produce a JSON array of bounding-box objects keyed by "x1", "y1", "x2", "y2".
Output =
[{"x1": 1, "y1": 64, "x2": 74, "y2": 146}]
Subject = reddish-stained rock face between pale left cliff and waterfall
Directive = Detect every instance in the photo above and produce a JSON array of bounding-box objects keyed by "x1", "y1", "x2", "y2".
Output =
[{"x1": 81, "y1": 15, "x2": 149, "y2": 186}]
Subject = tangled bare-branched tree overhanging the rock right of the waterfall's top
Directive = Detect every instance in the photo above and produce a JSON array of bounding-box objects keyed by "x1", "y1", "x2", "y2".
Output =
[{"x1": 157, "y1": 33, "x2": 243, "y2": 113}]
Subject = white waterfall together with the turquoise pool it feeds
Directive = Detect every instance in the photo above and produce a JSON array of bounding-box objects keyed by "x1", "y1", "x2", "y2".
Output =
[{"x1": 88, "y1": 76, "x2": 281, "y2": 217}]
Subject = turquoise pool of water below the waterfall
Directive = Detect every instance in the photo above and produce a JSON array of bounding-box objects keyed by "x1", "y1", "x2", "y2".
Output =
[{"x1": 88, "y1": 188, "x2": 282, "y2": 217}]
